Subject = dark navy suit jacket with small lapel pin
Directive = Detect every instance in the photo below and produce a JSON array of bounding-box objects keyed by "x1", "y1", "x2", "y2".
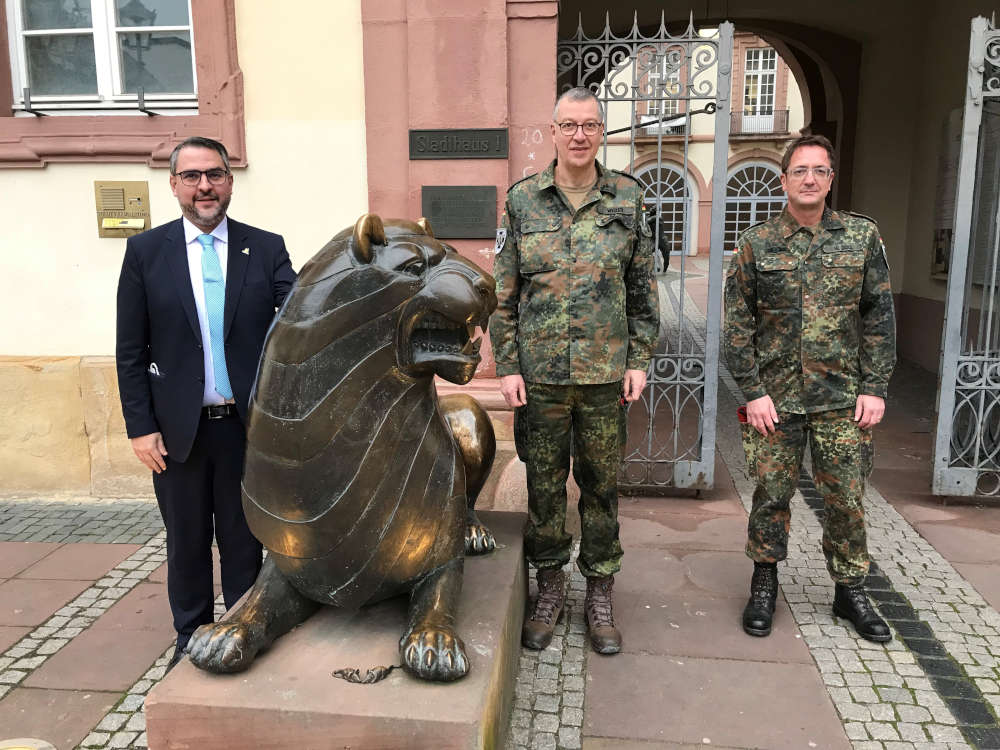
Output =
[{"x1": 116, "y1": 219, "x2": 295, "y2": 461}]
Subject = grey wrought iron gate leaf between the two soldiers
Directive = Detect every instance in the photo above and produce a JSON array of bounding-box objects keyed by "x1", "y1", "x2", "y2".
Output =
[{"x1": 557, "y1": 15, "x2": 733, "y2": 489}]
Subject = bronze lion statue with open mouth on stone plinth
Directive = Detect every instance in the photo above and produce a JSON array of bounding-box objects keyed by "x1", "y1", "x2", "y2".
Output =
[{"x1": 188, "y1": 214, "x2": 496, "y2": 680}]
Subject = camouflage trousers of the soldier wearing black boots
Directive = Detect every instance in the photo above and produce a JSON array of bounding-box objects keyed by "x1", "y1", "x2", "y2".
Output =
[{"x1": 742, "y1": 408, "x2": 873, "y2": 585}]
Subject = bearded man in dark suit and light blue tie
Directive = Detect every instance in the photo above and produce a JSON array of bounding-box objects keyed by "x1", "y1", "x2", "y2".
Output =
[{"x1": 117, "y1": 138, "x2": 295, "y2": 666}]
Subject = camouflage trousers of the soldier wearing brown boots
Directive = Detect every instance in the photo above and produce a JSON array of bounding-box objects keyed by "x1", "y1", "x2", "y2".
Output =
[{"x1": 514, "y1": 382, "x2": 625, "y2": 578}]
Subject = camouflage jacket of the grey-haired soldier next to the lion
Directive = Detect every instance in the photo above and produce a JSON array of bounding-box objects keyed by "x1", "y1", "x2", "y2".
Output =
[{"x1": 490, "y1": 161, "x2": 659, "y2": 385}]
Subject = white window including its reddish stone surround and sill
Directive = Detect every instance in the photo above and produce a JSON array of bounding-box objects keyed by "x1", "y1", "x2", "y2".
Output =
[{"x1": 0, "y1": 0, "x2": 246, "y2": 167}]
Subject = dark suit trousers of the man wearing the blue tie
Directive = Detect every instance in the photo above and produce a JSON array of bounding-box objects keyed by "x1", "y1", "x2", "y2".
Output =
[{"x1": 153, "y1": 413, "x2": 262, "y2": 648}]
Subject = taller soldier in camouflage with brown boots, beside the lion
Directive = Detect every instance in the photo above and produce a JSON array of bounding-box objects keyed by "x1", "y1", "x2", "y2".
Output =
[{"x1": 490, "y1": 88, "x2": 659, "y2": 653}]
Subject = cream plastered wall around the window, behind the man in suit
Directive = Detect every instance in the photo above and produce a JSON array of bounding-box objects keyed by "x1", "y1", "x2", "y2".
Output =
[{"x1": 0, "y1": 0, "x2": 368, "y2": 355}]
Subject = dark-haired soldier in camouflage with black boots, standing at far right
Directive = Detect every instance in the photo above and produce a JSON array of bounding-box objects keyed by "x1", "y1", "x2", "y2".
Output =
[{"x1": 725, "y1": 136, "x2": 896, "y2": 642}]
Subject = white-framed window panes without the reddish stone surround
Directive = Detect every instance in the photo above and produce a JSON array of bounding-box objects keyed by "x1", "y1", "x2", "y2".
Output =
[{"x1": 8, "y1": 0, "x2": 197, "y2": 111}]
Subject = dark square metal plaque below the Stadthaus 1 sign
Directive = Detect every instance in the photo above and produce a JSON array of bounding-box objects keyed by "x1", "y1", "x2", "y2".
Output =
[{"x1": 420, "y1": 185, "x2": 497, "y2": 239}]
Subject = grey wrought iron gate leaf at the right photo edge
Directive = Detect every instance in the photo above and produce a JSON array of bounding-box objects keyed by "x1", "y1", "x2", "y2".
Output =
[{"x1": 934, "y1": 17, "x2": 1000, "y2": 495}]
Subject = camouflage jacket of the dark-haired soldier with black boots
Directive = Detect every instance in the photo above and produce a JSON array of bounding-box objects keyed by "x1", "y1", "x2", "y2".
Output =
[{"x1": 724, "y1": 208, "x2": 896, "y2": 414}]
